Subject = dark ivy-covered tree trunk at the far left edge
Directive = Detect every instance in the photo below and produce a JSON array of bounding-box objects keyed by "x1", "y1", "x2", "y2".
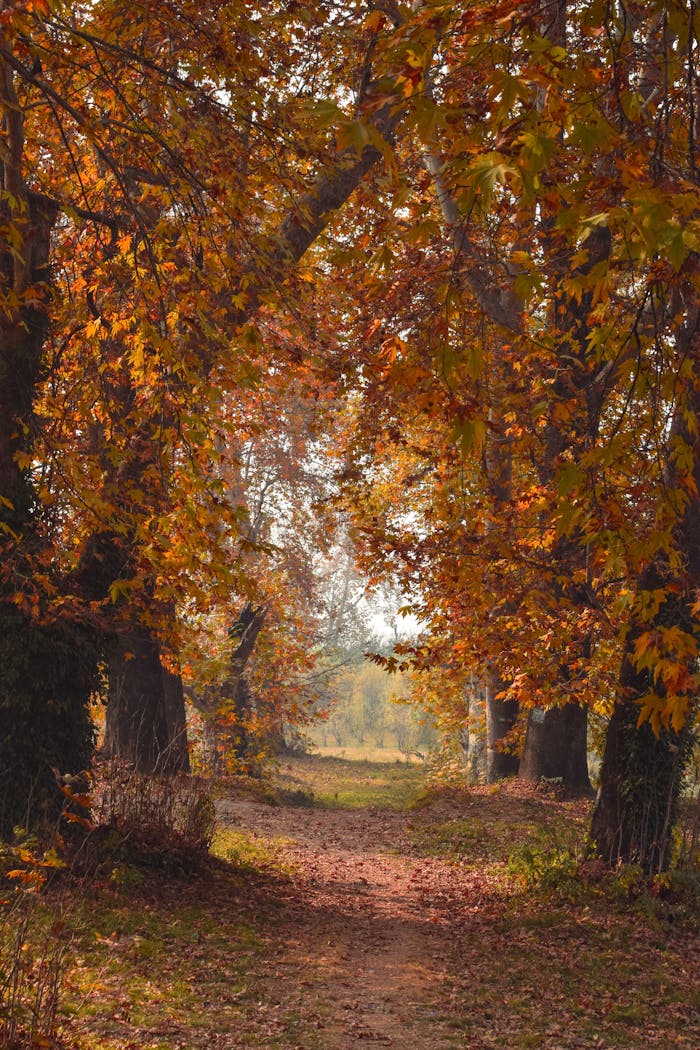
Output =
[{"x1": 0, "y1": 180, "x2": 97, "y2": 838}]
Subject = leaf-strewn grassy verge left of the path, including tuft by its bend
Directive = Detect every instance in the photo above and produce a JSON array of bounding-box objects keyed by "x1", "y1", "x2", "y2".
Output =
[{"x1": 52, "y1": 856, "x2": 304, "y2": 1050}]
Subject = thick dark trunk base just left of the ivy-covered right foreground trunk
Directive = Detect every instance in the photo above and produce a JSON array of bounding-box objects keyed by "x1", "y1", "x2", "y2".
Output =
[{"x1": 518, "y1": 704, "x2": 592, "y2": 795}]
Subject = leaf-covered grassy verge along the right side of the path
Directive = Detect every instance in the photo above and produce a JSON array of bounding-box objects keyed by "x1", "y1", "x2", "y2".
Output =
[{"x1": 405, "y1": 784, "x2": 700, "y2": 1050}]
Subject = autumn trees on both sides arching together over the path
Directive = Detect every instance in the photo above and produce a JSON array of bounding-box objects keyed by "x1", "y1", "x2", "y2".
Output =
[{"x1": 0, "y1": 0, "x2": 700, "y2": 869}]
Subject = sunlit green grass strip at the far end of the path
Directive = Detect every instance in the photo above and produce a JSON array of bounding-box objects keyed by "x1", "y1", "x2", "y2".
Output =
[{"x1": 275, "y1": 755, "x2": 424, "y2": 810}]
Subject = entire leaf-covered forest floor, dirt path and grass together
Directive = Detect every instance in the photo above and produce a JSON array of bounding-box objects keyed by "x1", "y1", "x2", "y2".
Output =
[{"x1": 23, "y1": 758, "x2": 700, "y2": 1050}]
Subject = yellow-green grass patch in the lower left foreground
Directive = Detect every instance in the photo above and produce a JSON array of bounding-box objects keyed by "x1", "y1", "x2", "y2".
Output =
[{"x1": 55, "y1": 873, "x2": 272, "y2": 1050}]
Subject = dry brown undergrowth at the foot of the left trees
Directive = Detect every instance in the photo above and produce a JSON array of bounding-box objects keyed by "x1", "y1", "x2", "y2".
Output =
[{"x1": 0, "y1": 767, "x2": 219, "y2": 1050}]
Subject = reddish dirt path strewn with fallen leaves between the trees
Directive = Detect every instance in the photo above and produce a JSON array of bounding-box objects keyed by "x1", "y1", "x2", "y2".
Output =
[{"x1": 221, "y1": 801, "x2": 478, "y2": 1050}]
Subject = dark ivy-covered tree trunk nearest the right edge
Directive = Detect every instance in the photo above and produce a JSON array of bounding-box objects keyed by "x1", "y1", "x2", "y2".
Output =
[{"x1": 591, "y1": 294, "x2": 700, "y2": 873}]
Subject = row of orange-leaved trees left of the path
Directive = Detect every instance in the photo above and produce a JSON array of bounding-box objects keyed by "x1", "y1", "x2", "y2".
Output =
[{"x1": 0, "y1": 2, "x2": 369, "y2": 833}]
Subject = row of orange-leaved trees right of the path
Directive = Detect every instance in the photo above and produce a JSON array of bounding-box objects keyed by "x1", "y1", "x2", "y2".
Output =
[{"x1": 329, "y1": 2, "x2": 699, "y2": 869}]
